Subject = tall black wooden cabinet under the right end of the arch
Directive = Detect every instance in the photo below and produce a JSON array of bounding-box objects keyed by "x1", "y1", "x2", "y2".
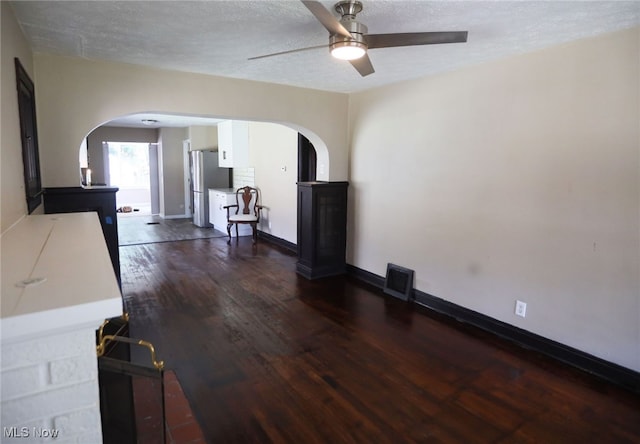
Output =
[{"x1": 296, "y1": 182, "x2": 349, "y2": 279}]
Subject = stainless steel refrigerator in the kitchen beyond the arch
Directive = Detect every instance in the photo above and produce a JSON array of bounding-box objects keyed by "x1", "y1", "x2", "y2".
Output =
[{"x1": 189, "y1": 151, "x2": 230, "y2": 227}]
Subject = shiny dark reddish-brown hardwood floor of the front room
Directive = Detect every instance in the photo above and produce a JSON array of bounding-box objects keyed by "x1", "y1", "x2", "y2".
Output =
[{"x1": 120, "y1": 237, "x2": 640, "y2": 443}]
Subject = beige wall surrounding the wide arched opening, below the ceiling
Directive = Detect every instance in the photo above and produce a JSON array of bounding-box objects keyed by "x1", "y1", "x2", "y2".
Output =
[{"x1": 34, "y1": 54, "x2": 348, "y2": 187}]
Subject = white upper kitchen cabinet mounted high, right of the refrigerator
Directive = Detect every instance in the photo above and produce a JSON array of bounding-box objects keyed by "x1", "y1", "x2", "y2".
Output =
[{"x1": 218, "y1": 120, "x2": 249, "y2": 168}]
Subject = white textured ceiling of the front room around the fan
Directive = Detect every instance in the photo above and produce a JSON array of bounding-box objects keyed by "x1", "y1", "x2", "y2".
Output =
[{"x1": 12, "y1": 0, "x2": 640, "y2": 115}]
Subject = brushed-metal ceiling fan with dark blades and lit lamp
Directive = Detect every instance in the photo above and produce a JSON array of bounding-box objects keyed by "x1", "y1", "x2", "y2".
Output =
[{"x1": 249, "y1": 0, "x2": 467, "y2": 77}]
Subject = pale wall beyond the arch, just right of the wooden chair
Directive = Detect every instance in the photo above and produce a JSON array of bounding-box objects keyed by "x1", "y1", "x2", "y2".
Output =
[{"x1": 249, "y1": 122, "x2": 298, "y2": 243}]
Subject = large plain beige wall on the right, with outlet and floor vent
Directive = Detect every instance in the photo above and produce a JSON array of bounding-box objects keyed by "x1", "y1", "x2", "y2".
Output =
[{"x1": 348, "y1": 28, "x2": 640, "y2": 370}]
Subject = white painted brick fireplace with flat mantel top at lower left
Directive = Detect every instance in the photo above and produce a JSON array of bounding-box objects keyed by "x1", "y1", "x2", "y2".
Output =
[{"x1": 0, "y1": 212, "x2": 122, "y2": 442}]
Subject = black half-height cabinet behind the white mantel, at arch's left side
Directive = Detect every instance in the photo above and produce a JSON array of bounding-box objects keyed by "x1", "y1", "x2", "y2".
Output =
[{"x1": 44, "y1": 187, "x2": 121, "y2": 285}]
